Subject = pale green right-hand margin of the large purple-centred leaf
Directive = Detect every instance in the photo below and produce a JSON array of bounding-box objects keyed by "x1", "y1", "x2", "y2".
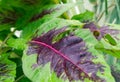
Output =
[{"x1": 75, "y1": 29, "x2": 115, "y2": 82}]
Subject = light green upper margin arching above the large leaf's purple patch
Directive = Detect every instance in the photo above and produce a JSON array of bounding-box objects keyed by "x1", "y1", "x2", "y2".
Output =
[{"x1": 38, "y1": 18, "x2": 83, "y2": 35}]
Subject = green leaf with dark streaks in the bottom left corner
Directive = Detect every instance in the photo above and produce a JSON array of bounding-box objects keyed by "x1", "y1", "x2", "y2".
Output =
[{"x1": 0, "y1": 54, "x2": 16, "y2": 82}]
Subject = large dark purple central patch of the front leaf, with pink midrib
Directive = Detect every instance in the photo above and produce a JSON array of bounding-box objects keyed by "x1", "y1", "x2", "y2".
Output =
[{"x1": 27, "y1": 28, "x2": 104, "y2": 82}]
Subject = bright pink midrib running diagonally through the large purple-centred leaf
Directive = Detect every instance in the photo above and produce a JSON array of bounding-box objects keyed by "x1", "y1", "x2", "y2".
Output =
[{"x1": 31, "y1": 41, "x2": 89, "y2": 77}]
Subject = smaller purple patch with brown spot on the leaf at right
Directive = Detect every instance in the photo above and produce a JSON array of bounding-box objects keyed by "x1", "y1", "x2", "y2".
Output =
[{"x1": 83, "y1": 22, "x2": 120, "y2": 40}]
